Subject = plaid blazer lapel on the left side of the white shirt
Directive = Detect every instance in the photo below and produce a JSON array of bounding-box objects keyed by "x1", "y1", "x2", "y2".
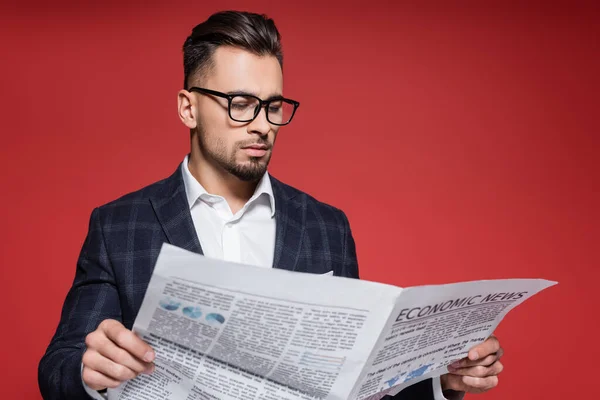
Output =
[{"x1": 150, "y1": 165, "x2": 203, "y2": 254}]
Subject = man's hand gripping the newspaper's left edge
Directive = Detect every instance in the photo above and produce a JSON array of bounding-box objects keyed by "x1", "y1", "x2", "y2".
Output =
[{"x1": 82, "y1": 319, "x2": 155, "y2": 390}]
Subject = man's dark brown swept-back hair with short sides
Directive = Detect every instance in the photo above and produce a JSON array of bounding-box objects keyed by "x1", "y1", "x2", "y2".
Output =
[{"x1": 183, "y1": 11, "x2": 283, "y2": 89}]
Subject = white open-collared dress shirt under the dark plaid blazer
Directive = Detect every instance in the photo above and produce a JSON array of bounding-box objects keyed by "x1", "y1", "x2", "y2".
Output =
[{"x1": 82, "y1": 156, "x2": 454, "y2": 400}]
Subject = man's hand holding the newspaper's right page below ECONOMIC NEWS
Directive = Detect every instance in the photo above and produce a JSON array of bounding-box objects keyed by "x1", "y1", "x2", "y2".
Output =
[{"x1": 440, "y1": 335, "x2": 504, "y2": 393}]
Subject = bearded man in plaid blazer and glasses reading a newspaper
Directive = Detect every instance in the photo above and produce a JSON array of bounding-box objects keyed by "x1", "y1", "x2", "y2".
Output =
[{"x1": 39, "y1": 12, "x2": 502, "y2": 399}]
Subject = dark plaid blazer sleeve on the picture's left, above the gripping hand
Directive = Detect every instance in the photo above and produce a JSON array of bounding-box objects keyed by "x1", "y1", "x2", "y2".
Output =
[{"x1": 38, "y1": 209, "x2": 121, "y2": 400}]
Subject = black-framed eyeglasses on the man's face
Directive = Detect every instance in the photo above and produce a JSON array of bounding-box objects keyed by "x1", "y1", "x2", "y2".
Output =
[{"x1": 188, "y1": 87, "x2": 300, "y2": 126}]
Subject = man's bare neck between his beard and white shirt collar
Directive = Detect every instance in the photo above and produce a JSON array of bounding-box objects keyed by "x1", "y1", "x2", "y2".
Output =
[{"x1": 188, "y1": 154, "x2": 258, "y2": 214}]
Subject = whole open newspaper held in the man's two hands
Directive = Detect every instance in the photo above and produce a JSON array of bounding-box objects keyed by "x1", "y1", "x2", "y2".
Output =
[{"x1": 108, "y1": 244, "x2": 556, "y2": 400}]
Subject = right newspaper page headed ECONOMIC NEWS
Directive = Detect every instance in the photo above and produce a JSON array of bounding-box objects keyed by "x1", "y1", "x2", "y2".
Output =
[{"x1": 350, "y1": 279, "x2": 555, "y2": 400}]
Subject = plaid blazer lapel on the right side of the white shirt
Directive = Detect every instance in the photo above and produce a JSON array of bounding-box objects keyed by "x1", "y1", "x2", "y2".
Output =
[{"x1": 270, "y1": 177, "x2": 306, "y2": 271}]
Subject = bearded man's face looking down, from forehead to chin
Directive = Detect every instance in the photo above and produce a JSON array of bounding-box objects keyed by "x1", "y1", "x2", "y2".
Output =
[{"x1": 192, "y1": 46, "x2": 283, "y2": 181}]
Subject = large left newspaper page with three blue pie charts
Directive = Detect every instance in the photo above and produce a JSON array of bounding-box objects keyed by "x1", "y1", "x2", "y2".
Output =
[{"x1": 109, "y1": 245, "x2": 399, "y2": 400}]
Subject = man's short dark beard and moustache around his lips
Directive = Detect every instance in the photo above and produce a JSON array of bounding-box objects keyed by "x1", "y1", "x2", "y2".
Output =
[{"x1": 198, "y1": 127, "x2": 272, "y2": 182}]
